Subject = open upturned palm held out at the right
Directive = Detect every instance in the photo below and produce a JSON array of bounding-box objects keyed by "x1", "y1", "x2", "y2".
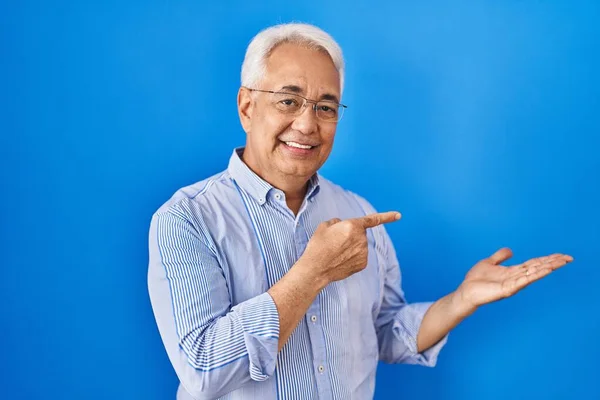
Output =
[{"x1": 457, "y1": 248, "x2": 573, "y2": 313}]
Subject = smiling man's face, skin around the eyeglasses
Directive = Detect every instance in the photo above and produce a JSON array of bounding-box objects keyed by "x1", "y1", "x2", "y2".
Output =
[{"x1": 238, "y1": 43, "x2": 340, "y2": 184}]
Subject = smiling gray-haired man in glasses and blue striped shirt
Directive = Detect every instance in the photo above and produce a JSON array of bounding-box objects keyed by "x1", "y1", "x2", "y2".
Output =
[{"x1": 148, "y1": 24, "x2": 572, "y2": 400}]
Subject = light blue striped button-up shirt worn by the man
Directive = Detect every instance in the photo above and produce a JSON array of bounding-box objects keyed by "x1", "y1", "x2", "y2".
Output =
[{"x1": 148, "y1": 148, "x2": 447, "y2": 400}]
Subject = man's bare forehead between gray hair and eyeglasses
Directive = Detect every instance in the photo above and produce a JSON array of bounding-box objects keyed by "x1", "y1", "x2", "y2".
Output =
[{"x1": 264, "y1": 43, "x2": 340, "y2": 98}]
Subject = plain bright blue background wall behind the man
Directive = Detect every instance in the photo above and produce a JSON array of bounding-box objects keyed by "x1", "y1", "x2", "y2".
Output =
[{"x1": 0, "y1": 1, "x2": 600, "y2": 399}]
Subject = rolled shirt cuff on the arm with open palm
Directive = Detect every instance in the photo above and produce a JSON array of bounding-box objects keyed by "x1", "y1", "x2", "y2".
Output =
[{"x1": 392, "y1": 302, "x2": 448, "y2": 367}]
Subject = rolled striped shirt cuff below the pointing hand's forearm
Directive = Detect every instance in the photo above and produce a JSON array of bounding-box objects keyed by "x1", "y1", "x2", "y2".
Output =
[{"x1": 232, "y1": 292, "x2": 279, "y2": 381}]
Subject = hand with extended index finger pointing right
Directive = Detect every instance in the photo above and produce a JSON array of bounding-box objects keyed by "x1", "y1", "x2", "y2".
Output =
[{"x1": 298, "y1": 211, "x2": 400, "y2": 287}]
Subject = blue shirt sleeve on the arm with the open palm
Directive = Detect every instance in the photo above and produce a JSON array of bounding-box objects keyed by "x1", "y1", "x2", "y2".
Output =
[{"x1": 357, "y1": 196, "x2": 448, "y2": 367}]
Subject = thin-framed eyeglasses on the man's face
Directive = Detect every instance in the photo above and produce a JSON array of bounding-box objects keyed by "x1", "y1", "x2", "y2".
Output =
[{"x1": 246, "y1": 88, "x2": 348, "y2": 122}]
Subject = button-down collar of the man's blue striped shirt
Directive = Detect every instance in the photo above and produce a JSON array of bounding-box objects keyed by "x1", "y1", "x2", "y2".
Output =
[{"x1": 227, "y1": 147, "x2": 319, "y2": 205}]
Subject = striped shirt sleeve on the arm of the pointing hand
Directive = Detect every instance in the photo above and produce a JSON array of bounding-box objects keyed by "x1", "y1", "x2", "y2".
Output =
[{"x1": 148, "y1": 211, "x2": 279, "y2": 399}]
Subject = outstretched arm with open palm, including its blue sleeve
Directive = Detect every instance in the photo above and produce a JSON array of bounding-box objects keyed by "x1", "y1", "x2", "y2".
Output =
[{"x1": 366, "y1": 199, "x2": 573, "y2": 366}]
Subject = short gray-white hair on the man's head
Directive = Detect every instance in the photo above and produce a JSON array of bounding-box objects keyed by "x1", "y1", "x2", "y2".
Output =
[{"x1": 242, "y1": 23, "x2": 344, "y2": 92}]
